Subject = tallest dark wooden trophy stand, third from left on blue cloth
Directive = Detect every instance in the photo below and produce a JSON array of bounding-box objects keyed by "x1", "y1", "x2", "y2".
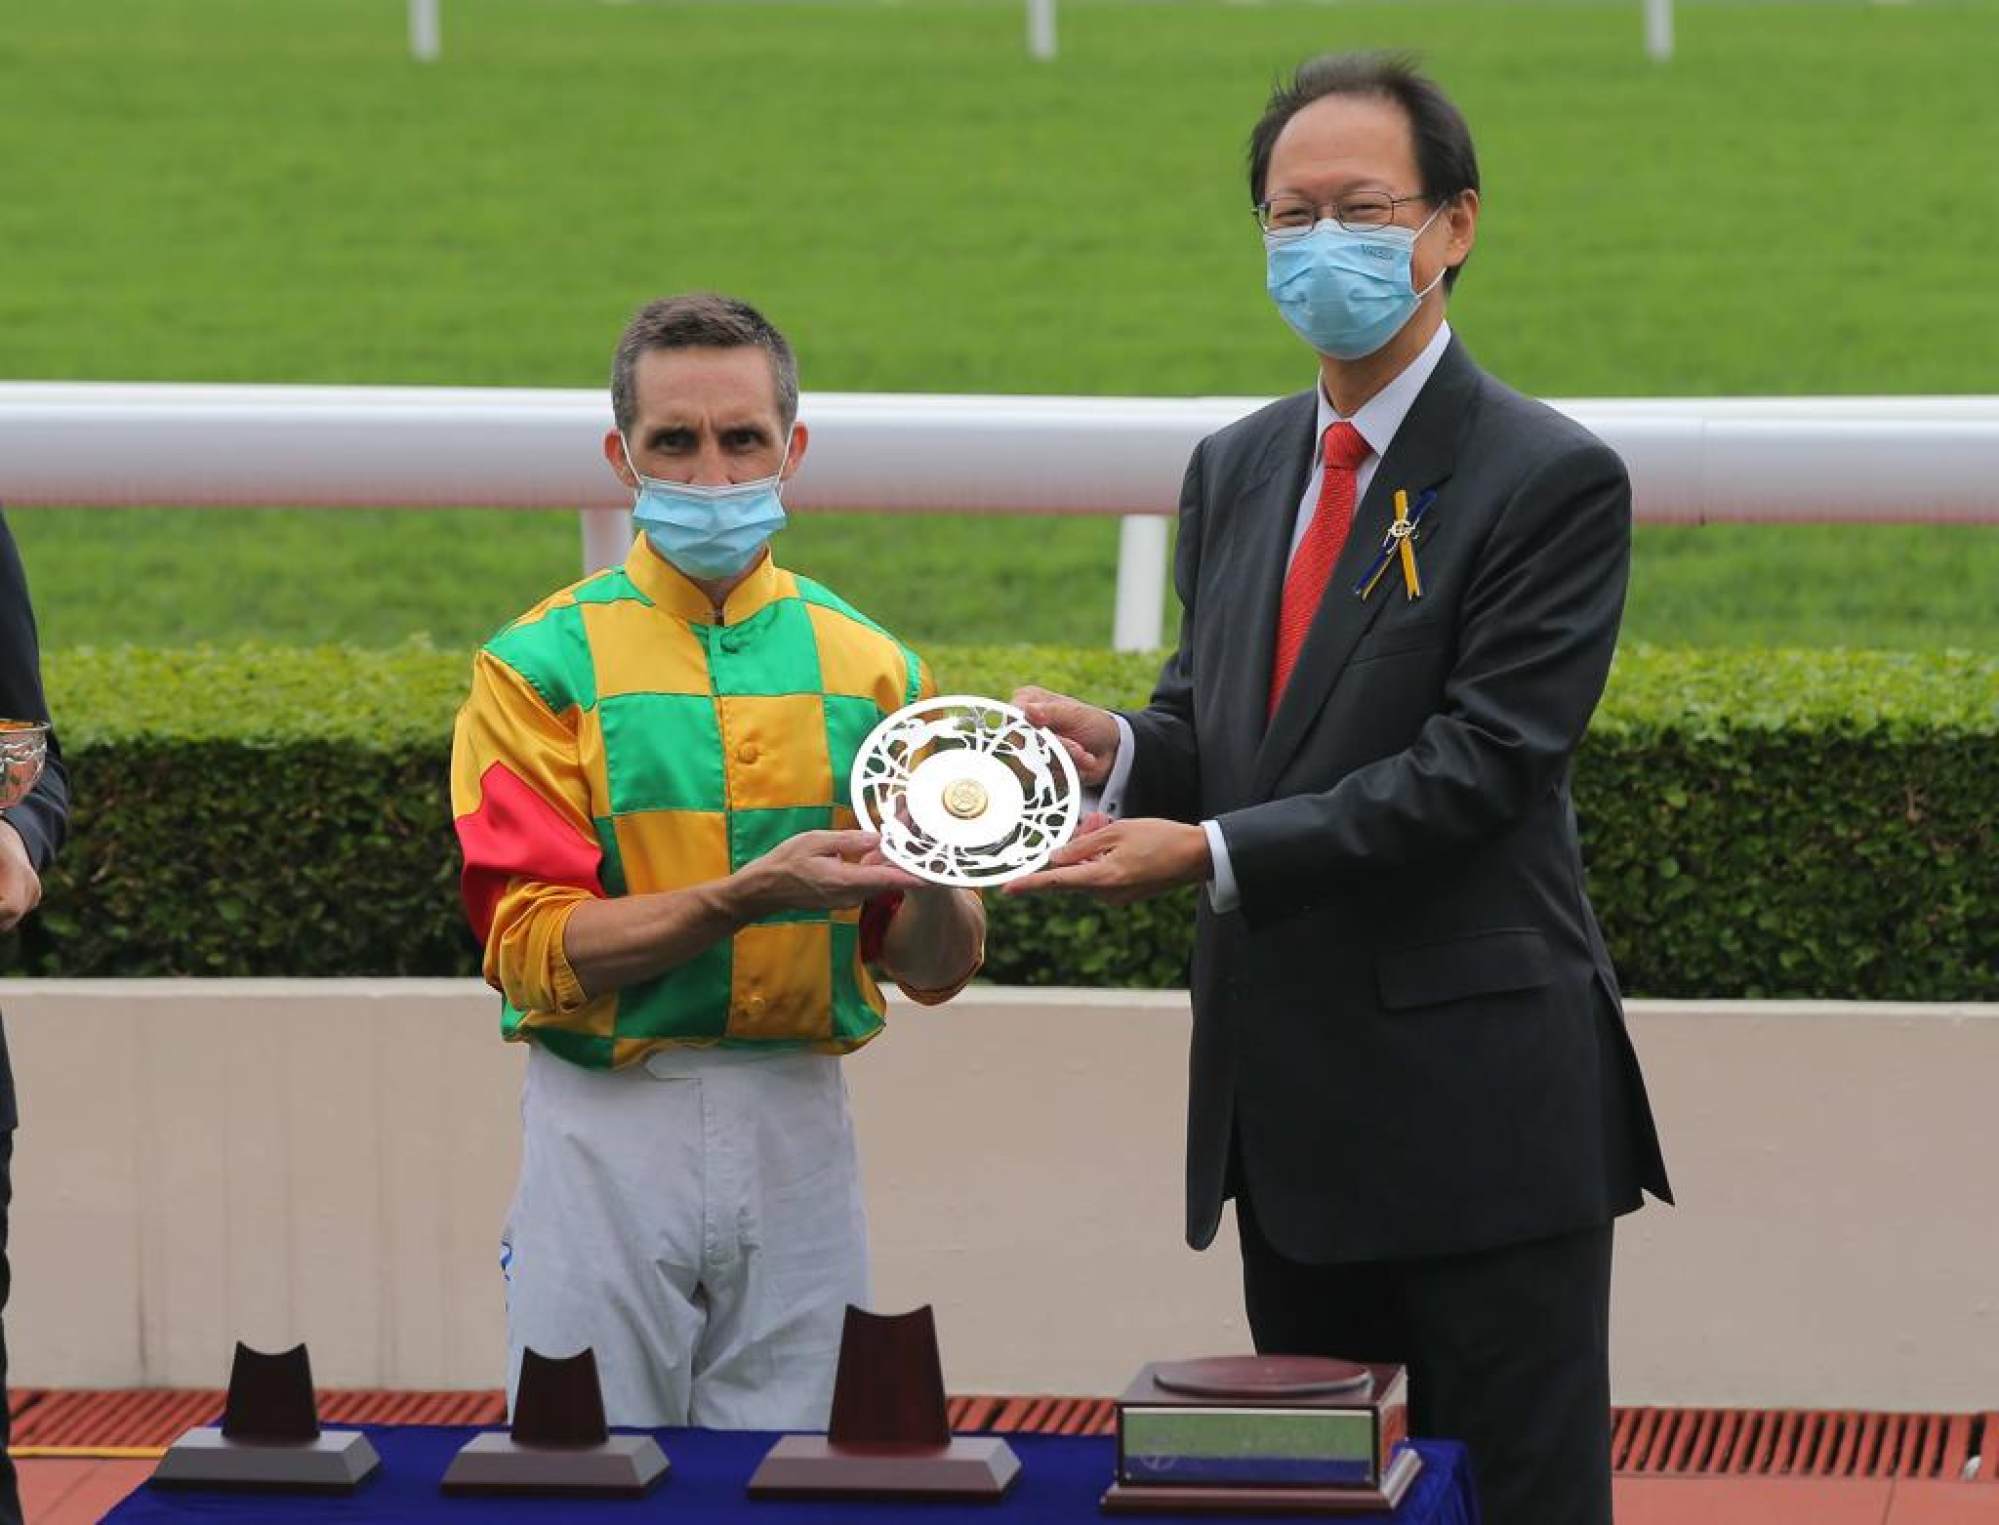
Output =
[{"x1": 750, "y1": 1307, "x2": 1019, "y2": 1503}]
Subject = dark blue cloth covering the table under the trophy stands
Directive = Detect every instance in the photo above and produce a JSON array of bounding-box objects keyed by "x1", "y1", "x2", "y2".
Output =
[{"x1": 106, "y1": 1425, "x2": 1479, "y2": 1525}]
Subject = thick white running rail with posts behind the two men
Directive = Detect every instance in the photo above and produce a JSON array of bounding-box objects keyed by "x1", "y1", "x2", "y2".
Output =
[{"x1": 0, "y1": 382, "x2": 1999, "y2": 650}]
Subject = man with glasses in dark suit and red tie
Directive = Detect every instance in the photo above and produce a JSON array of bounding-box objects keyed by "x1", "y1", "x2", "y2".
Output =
[{"x1": 1013, "y1": 56, "x2": 1669, "y2": 1525}]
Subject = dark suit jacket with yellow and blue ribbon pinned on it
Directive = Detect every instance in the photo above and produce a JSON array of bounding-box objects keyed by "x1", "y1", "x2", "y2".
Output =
[{"x1": 1125, "y1": 338, "x2": 1671, "y2": 1263}]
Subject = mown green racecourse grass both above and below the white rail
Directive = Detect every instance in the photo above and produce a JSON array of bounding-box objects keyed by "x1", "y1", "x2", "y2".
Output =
[{"x1": 0, "y1": 0, "x2": 1999, "y2": 646}]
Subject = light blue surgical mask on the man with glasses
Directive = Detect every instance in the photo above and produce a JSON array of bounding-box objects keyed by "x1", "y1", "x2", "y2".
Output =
[{"x1": 1263, "y1": 206, "x2": 1443, "y2": 360}]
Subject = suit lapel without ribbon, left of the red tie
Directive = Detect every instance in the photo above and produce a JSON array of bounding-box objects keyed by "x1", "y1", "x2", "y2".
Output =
[{"x1": 1219, "y1": 390, "x2": 1319, "y2": 777}]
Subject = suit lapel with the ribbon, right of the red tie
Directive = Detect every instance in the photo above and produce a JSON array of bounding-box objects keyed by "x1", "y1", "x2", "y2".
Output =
[{"x1": 1249, "y1": 338, "x2": 1477, "y2": 799}]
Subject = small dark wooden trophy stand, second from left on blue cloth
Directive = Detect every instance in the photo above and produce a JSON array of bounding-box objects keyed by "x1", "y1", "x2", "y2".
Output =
[{"x1": 444, "y1": 1345, "x2": 668, "y2": 1499}]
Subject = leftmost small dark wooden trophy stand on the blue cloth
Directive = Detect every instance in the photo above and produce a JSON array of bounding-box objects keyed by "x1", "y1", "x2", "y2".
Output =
[{"x1": 152, "y1": 1341, "x2": 382, "y2": 1493}]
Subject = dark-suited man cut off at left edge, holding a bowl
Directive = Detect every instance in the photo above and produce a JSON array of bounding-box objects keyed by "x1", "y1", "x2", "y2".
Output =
[{"x1": 0, "y1": 518, "x2": 70, "y2": 1525}]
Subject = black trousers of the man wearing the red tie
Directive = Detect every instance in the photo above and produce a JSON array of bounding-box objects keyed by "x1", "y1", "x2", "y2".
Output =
[{"x1": 1235, "y1": 1195, "x2": 1611, "y2": 1525}]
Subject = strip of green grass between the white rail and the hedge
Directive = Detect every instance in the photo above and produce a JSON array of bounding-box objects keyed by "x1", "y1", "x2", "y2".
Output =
[{"x1": 8, "y1": 510, "x2": 1999, "y2": 652}]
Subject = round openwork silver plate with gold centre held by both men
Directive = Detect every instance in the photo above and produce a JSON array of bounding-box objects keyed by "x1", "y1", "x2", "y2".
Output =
[{"x1": 850, "y1": 694, "x2": 1083, "y2": 889}]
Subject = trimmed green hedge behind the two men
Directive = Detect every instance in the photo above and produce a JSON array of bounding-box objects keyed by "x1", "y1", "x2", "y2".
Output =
[{"x1": 0, "y1": 646, "x2": 1999, "y2": 999}]
